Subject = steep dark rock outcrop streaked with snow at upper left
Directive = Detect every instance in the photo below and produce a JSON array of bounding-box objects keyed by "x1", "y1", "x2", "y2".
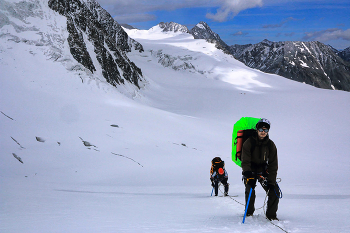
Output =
[{"x1": 48, "y1": 0, "x2": 143, "y2": 87}]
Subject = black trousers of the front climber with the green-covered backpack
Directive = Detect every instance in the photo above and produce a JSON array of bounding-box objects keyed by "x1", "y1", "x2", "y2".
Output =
[{"x1": 245, "y1": 180, "x2": 280, "y2": 218}]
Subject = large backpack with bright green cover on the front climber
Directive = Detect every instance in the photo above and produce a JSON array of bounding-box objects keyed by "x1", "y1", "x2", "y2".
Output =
[{"x1": 232, "y1": 117, "x2": 260, "y2": 167}]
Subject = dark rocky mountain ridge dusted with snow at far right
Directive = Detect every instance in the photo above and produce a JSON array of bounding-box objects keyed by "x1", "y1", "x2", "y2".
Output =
[{"x1": 231, "y1": 40, "x2": 350, "y2": 91}]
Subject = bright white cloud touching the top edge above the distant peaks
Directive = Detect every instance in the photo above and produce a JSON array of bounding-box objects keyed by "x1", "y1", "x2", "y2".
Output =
[{"x1": 206, "y1": 0, "x2": 263, "y2": 22}]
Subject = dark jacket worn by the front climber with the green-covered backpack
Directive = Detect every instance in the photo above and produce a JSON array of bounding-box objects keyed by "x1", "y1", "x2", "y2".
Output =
[{"x1": 242, "y1": 133, "x2": 278, "y2": 184}]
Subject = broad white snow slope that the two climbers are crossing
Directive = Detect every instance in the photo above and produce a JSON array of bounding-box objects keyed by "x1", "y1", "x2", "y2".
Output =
[{"x1": 0, "y1": 2, "x2": 350, "y2": 233}]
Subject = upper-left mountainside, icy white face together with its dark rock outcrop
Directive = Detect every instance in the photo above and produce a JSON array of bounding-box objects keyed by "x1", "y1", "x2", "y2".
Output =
[{"x1": 0, "y1": 0, "x2": 142, "y2": 87}]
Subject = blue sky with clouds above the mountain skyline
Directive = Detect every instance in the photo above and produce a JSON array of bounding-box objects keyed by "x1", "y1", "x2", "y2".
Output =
[{"x1": 97, "y1": 0, "x2": 350, "y2": 49}]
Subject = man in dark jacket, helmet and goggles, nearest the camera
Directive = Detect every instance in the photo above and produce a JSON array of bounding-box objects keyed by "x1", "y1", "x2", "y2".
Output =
[{"x1": 242, "y1": 118, "x2": 280, "y2": 220}]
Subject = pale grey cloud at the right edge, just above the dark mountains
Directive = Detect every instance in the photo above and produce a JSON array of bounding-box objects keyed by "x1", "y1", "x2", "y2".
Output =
[{"x1": 303, "y1": 28, "x2": 350, "y2": 42}]
